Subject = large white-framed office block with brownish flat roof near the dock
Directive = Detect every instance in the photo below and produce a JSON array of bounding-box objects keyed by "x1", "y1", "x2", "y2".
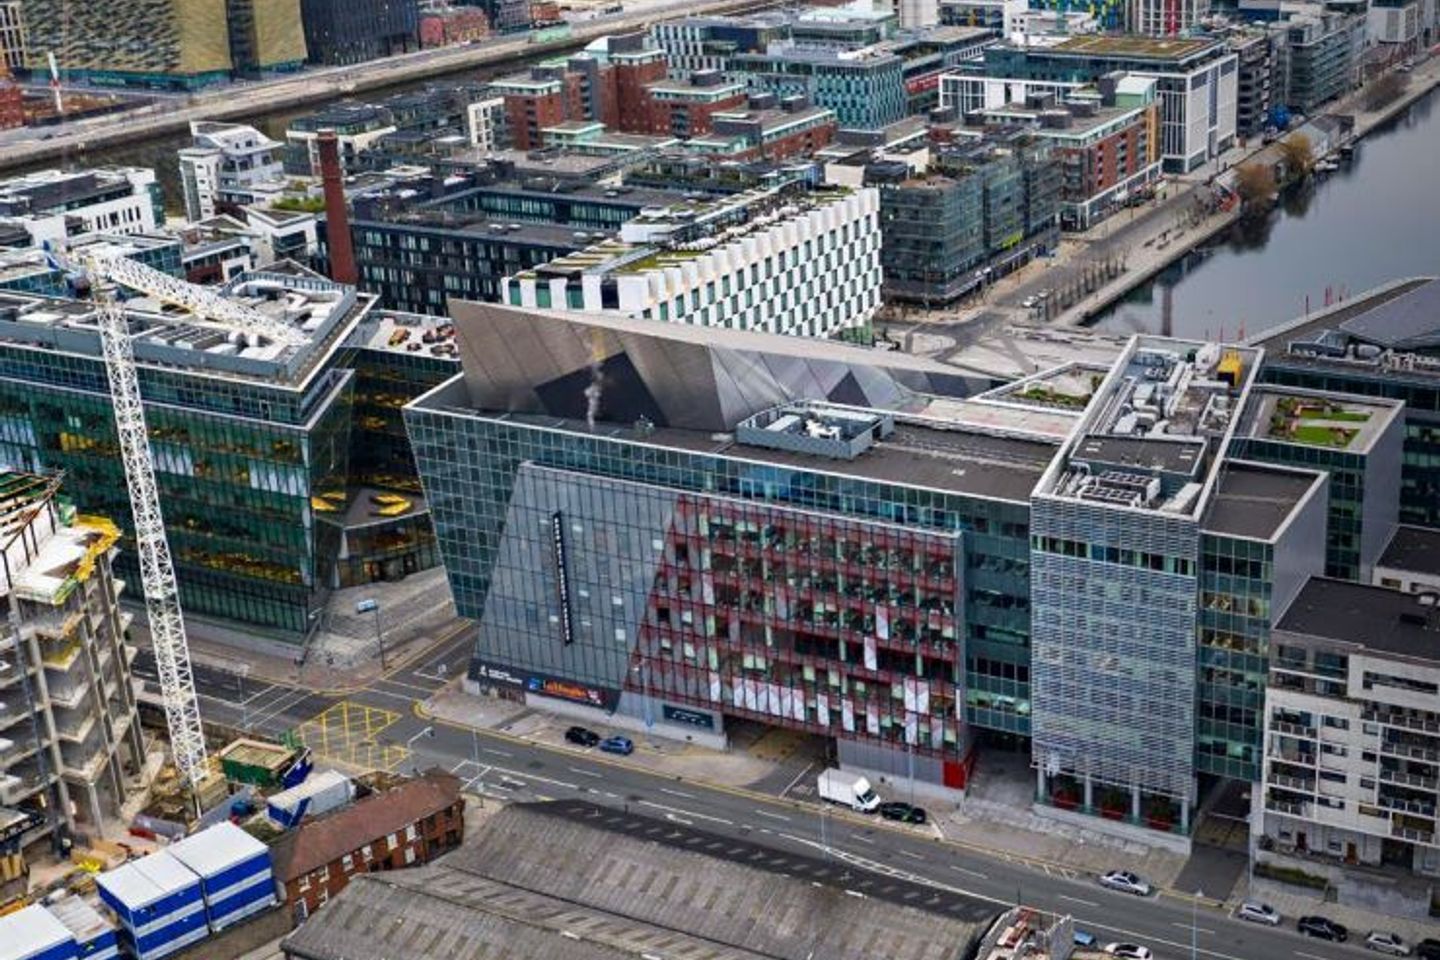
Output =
[{"x1": 979, "y1": 36, "x2": 1238, "y2": 173}]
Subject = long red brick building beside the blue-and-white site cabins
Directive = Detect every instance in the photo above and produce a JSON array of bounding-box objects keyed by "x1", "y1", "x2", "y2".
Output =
[{"x1": 271, "y1": 770, "x2": 465, "y2": 924}]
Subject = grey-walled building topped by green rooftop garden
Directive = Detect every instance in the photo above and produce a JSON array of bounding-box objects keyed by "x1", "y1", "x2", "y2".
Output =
[{"x1": 1231, "y1": 387, "x2": 1404, "y2": 583}]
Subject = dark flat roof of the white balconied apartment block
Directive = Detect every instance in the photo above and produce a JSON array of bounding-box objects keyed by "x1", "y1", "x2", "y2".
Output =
[{"x1": 1274, "y1": 577, "x2": 1440, "y2": 664}]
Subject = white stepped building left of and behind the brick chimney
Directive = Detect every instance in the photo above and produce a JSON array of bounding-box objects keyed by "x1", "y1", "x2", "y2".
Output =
[{"x1": 179, "y1": 121, "x2": 285, "y2": 220}]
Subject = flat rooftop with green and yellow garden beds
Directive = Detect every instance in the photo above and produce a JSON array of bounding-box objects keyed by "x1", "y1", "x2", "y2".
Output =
[{"x1": 1240, "y1": 386, "x2": 1401, "y2": 453}]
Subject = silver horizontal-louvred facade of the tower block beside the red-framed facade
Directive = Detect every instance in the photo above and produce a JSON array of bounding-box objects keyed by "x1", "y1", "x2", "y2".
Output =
[{"x1": 1030, "y1": 498, "x2": 1200, "y2": 799}]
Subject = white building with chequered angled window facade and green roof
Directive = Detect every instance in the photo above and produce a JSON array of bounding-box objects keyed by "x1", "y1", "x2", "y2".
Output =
[{"x1": 505, "y1": 186, "x2": 881, "y2": 337}]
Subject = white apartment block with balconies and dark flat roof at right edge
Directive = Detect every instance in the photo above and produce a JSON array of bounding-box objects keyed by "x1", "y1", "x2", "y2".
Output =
[{"x1": 1254, "y1": 579, "x2": 1440, "y2": 877}]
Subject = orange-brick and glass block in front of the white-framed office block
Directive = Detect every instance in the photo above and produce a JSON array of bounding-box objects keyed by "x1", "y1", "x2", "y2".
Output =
[{"x1": 982, "y1": 73, "x2": 1161, "y2": 230}]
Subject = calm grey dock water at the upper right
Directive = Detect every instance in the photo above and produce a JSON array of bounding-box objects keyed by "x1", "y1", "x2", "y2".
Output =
[{"x1": 1094, "y1": 84, "x2": 1440, "y2": 338}]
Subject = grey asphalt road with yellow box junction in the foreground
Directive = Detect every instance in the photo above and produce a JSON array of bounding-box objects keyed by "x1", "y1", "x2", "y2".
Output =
[{"x1": 134, "y1": 632, "x2": 1369, "y2": 960}]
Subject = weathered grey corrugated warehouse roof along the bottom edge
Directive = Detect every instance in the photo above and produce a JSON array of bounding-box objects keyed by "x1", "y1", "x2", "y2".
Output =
[{"x1": 285, "y1": 800, "x2": 999, "y2": 960}]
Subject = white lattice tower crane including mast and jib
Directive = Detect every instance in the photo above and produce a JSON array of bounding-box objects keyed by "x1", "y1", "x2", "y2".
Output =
[{"x1": 48, "y1": 250, "x2": 301, "y2": 790}]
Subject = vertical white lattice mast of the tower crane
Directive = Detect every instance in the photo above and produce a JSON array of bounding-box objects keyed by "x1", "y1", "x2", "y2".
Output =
[{"x1": 95, "y1": 283, "x2": 206, "y2": 787}]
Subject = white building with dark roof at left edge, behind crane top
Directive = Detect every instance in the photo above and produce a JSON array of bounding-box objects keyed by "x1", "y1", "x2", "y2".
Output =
[{"x1": 0, "y1": 167, "x2": 164, "y2": 246}]
